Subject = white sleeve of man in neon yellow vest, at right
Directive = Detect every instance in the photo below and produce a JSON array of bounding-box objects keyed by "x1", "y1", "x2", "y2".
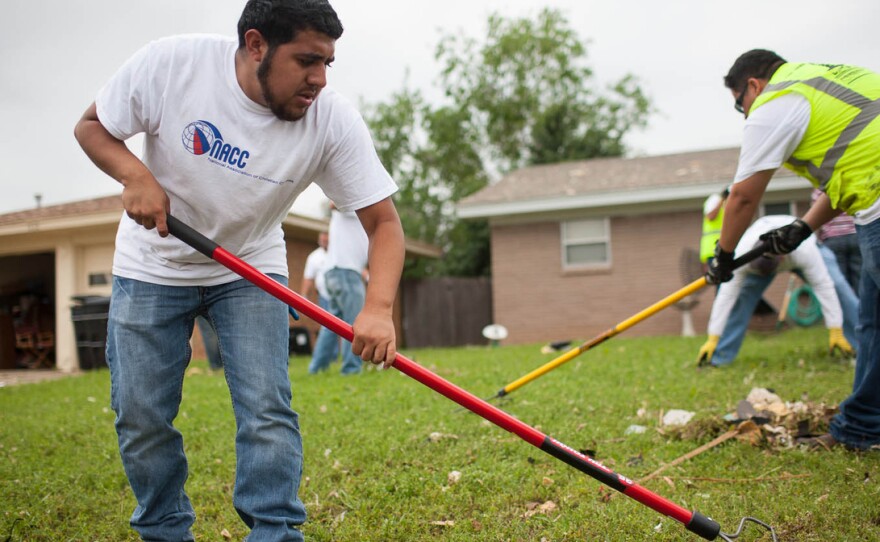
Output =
[{"x1": 733, "y1": 92, "x2": 810, "y2": 183}]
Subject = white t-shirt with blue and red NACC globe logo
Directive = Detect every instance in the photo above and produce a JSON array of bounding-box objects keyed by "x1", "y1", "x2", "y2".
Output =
[{"x1": 96, "y1": 35, "x2": 397, "y2": 286}]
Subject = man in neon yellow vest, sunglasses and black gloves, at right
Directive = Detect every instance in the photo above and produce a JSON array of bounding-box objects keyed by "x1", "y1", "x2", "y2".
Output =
[{"x1": 706, "y1": 49, "x2": 880, "y2": 450}]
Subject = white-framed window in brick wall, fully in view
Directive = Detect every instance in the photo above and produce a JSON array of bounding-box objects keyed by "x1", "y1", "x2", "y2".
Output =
[{"x1": 561, "y1": 218, "x2": 611, "y2": 269}]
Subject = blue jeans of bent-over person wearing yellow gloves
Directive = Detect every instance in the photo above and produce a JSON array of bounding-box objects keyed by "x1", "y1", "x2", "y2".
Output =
[{"x1": 712, "y1": 251, "x2": 859, "y2": 366}]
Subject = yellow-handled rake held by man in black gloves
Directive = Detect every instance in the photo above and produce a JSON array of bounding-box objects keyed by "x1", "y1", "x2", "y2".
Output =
[{"x1": 488, "y1": 244, "x2": 767, "y2": 401}]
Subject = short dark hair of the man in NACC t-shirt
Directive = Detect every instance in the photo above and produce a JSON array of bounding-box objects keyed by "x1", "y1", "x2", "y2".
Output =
[{"x1": 238, "y1": 0, "x2": 342, "y2": 49}]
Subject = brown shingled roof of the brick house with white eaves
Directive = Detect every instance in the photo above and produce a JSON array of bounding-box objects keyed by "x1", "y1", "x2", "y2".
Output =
[{"x1": 458, "y1": 148, "x2": 809, "y2": 218}]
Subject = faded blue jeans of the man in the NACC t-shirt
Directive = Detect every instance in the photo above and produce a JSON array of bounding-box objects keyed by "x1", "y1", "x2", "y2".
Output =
[{"x1": 107, "y1": 276, "x2": 306, "y2": 541}]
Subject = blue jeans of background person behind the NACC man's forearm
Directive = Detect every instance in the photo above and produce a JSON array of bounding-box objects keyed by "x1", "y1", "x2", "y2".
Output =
[{"x1": 309, "y1": 267, "x2": 367, "y2": 374}]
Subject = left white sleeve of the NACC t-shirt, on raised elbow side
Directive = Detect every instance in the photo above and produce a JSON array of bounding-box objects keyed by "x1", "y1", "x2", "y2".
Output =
[{"x1": 95, "y1": 42, "x2": 162, "y2": 140}]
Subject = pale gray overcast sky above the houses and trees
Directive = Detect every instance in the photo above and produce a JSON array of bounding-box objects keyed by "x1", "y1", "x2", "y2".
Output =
[{"x1": 0, "y1": 0, "x2": 880, "y2": 214}]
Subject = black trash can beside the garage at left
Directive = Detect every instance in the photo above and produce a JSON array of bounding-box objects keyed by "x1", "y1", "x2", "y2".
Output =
[{"x1": 70, "y1": 296, "x2": 110, "y2": 371}]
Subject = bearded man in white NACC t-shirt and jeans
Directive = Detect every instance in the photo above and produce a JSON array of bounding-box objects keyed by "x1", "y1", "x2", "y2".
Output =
[{"x1": 75, "y1": 0, "x2": 404, "y2": 540}]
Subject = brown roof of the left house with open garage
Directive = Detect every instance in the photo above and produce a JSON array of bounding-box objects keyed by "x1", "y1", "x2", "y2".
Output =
[{"x1": 0, "y1": 195, "x2": 443, "y2": 258}]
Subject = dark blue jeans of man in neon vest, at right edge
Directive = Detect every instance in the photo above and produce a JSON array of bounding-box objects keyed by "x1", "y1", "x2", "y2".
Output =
[{"x1": 831, "y1": 220, "x2": 880, "y2": 448}]
